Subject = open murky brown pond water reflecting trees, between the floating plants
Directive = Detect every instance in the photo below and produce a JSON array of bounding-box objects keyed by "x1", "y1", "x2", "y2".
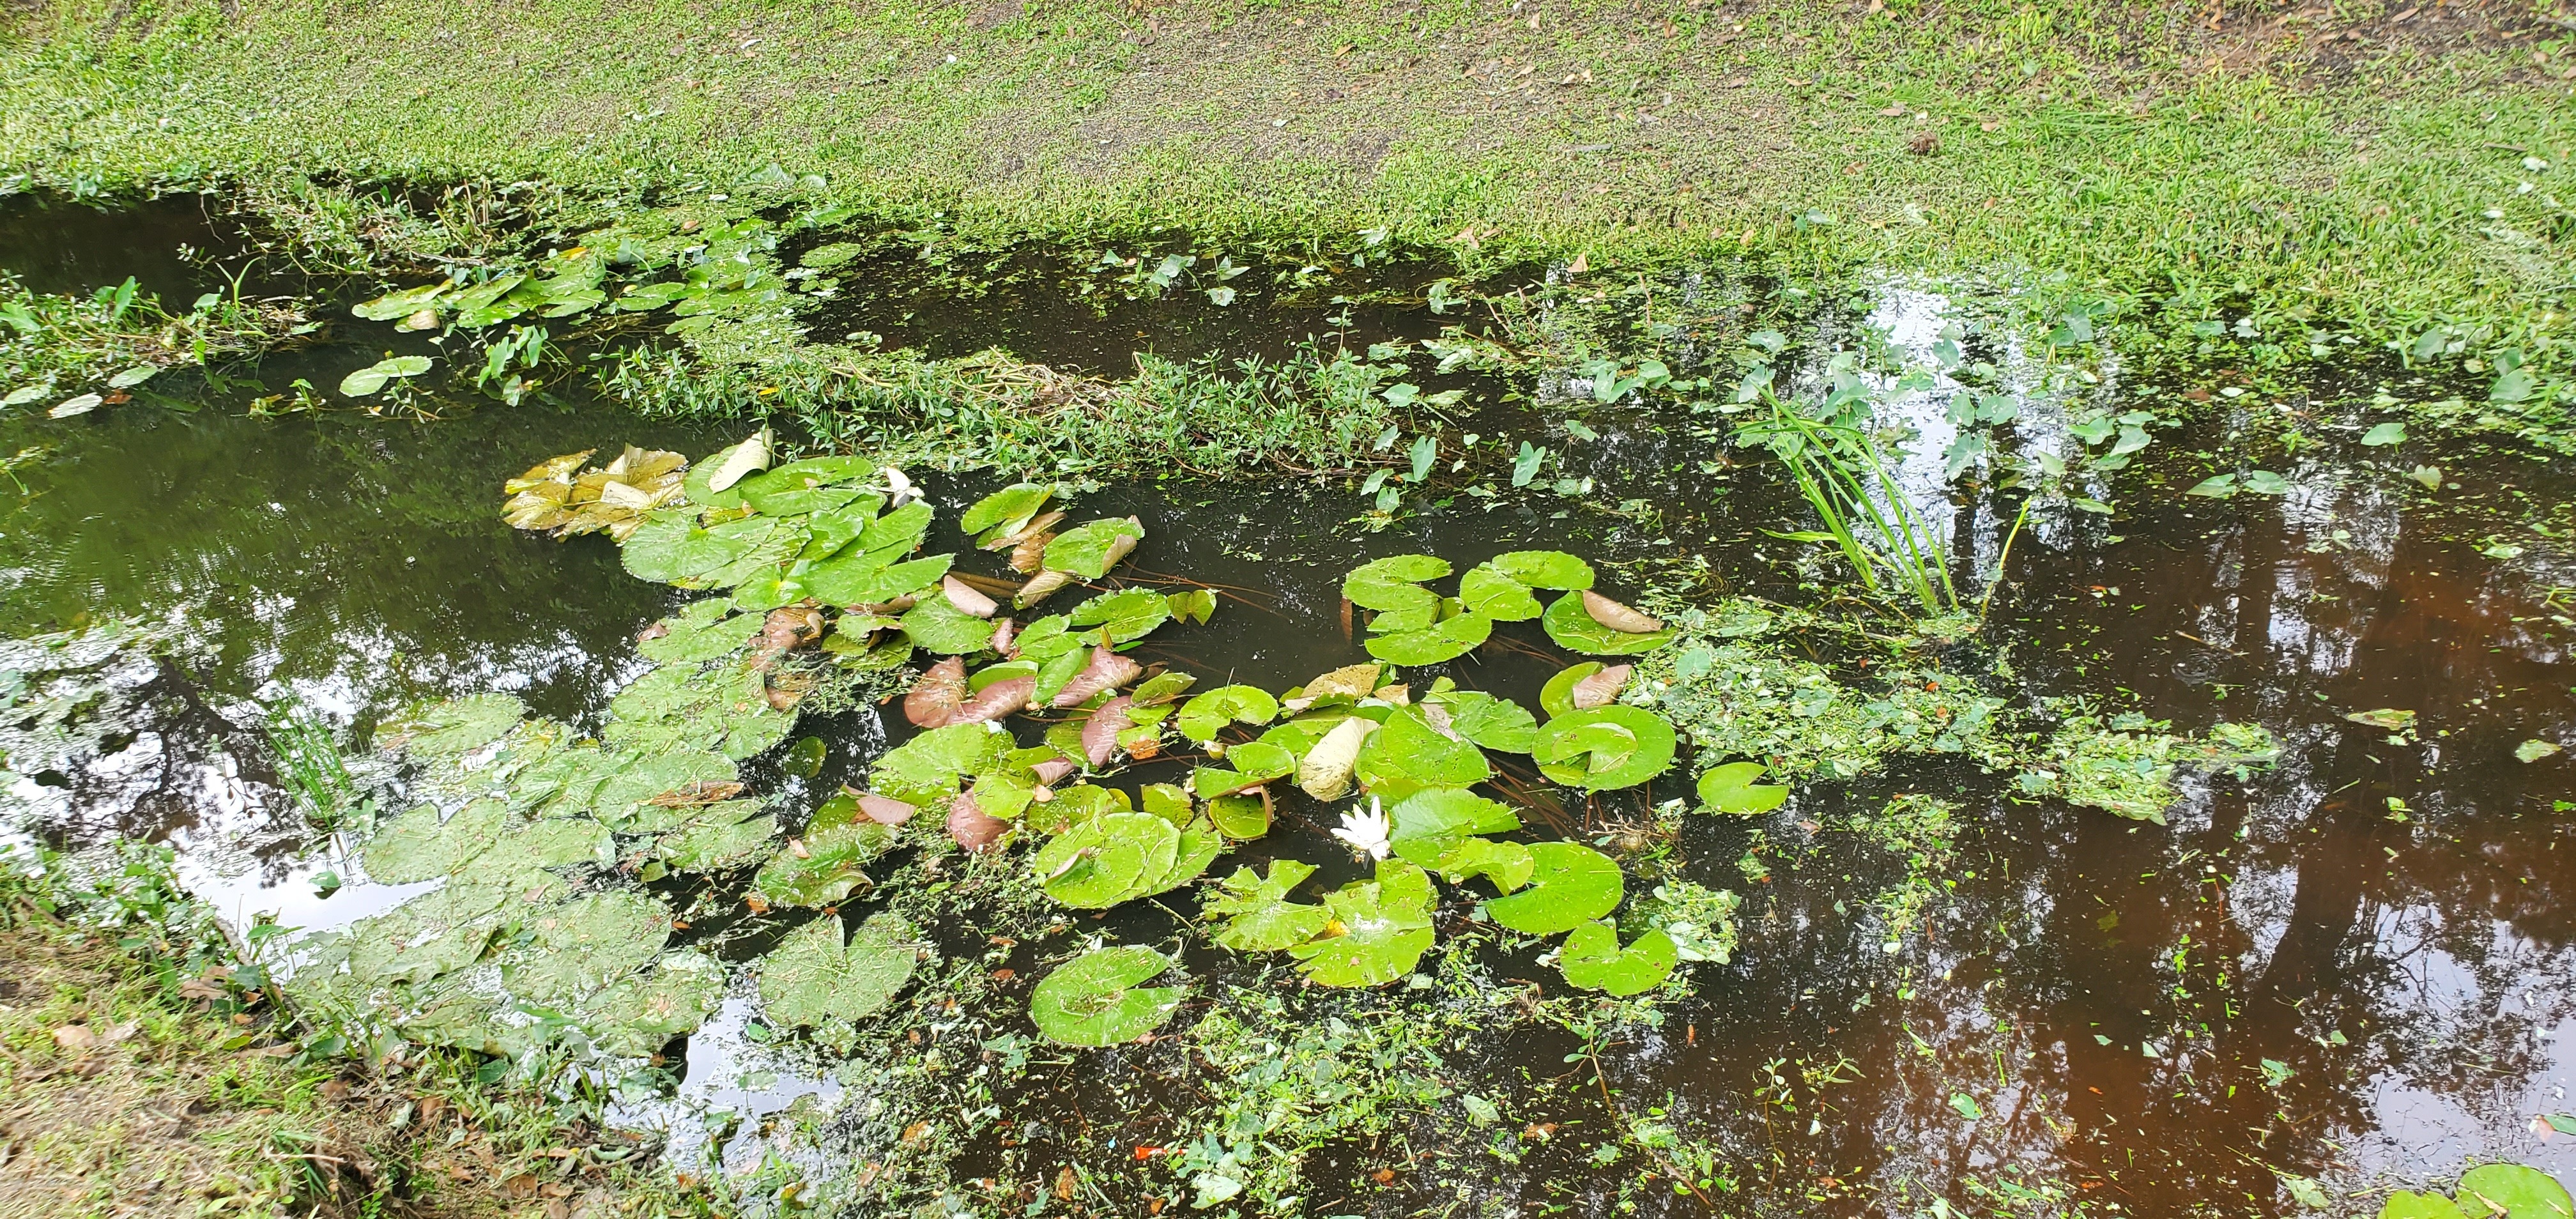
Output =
[{"x1": 0, "y1": 204, "x2": 2576, "y2": 1216}]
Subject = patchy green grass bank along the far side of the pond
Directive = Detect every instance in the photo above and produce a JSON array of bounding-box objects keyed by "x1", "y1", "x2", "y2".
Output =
[{"x1": 0, "y1": 0, "x2": 2576, "y2": 438}]
